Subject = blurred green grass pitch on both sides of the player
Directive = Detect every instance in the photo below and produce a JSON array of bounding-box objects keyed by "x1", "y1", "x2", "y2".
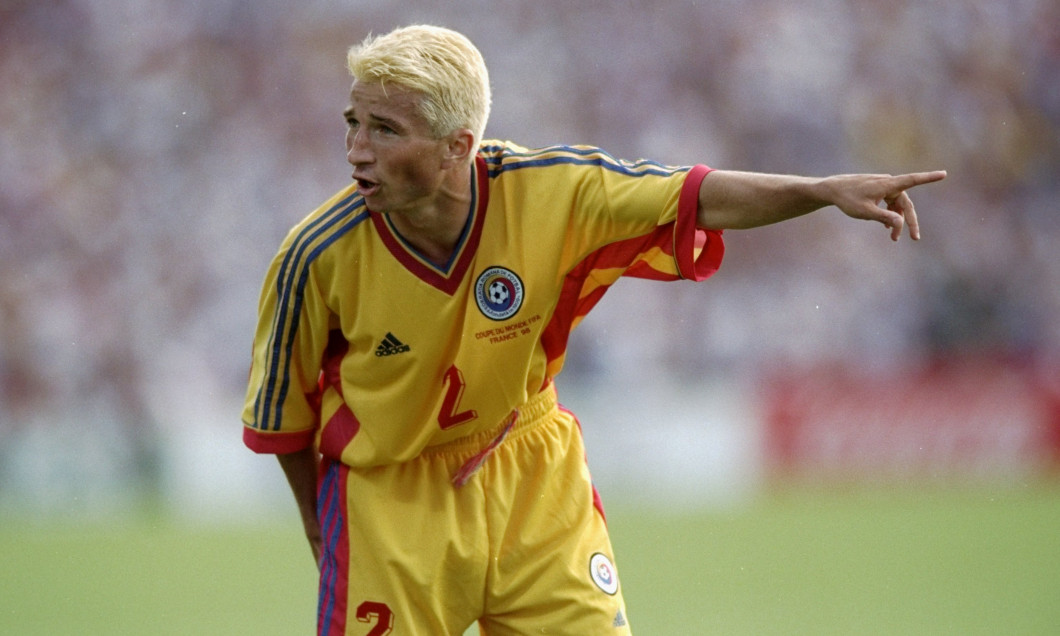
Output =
[{"x1": 0, "y1": 488, "x2": 1060, "y2": 636}]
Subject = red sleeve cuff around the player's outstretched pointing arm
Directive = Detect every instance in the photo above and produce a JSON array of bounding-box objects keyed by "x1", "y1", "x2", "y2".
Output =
[{"x1": 673, "y1": 165, "x2": 725, "y2": 281}]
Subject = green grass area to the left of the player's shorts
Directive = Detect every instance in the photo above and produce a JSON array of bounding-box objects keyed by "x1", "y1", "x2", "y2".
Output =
[{"x1": 0, "y1": 520, "x2": 316, "y2": 636}]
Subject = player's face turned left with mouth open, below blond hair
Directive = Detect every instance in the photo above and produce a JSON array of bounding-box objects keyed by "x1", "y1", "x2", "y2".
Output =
[{"x1": 346, "y1": 81, "x2": 446, "y2": 213}]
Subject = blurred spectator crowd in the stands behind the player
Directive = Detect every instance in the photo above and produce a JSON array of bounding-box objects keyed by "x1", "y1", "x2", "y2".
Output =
[{"x1": 0, "y1": 0, "x2": 1060, "y2": 509}]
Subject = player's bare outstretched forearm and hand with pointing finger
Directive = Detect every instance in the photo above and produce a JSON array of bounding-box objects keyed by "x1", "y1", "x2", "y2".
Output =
[{"x1": 697, "y1": 171, "x2": 946, "y2": 241}]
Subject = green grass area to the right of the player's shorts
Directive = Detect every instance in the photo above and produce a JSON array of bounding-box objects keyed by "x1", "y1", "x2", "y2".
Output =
[{"x1": 613, "y1": 489, "x2": 1060, "y2": 636}]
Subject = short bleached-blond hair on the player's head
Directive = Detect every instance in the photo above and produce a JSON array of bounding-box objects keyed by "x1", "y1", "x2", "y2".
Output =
[{"x1": 346, "y1": 24, "x2": 491, "y2": 142}]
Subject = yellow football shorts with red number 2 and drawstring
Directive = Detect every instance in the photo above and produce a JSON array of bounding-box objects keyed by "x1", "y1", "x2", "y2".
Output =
[{"x1": 318, "y1": 387, "x2": 630, "y2": 636}]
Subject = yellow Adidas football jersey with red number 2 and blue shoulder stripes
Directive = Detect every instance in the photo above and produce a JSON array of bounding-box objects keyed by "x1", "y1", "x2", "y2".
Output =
[{"x1": 243, "y1": 141, "x2": 724, "y2": 467}]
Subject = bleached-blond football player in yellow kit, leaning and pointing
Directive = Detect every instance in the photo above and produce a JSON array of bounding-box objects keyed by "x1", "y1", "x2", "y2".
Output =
[{"x1": 243, "y1": 27, "x2": 944, "y2": 635}]
